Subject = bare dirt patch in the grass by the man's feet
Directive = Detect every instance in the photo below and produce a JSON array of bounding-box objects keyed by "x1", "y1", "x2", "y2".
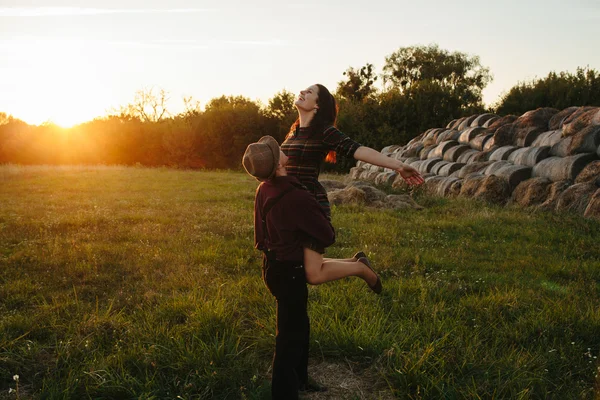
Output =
[{"x1": 300, "y1": 361, "x2": 395, "y2": 400}]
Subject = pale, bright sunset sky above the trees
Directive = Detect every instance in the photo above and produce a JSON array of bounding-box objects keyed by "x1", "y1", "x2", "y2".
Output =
[{"x1": 0, "y1": 0, "x2": 600, "y2": 126}]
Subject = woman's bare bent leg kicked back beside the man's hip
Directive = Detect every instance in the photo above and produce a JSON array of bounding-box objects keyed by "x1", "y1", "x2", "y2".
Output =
[{"x1": 304, "y1": 248, "x2": 377, "y2": 286}]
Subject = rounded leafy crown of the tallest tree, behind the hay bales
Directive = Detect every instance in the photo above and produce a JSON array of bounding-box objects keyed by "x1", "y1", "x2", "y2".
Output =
[{"x1": 383, "y1": 45, "x2": 492, "y2": 107}]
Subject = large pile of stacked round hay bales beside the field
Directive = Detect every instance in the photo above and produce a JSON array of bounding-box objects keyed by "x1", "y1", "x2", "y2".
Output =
[{"x1": 350, "y1": 107, "x2": 600, "y2": 219}]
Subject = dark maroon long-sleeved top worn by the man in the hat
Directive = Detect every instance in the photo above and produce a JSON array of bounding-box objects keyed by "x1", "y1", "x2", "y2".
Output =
[{"x1": 254, "y1": 176, "x2": 335, "y2": 262}]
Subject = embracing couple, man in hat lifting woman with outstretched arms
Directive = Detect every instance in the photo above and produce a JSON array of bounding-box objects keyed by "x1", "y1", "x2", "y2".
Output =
[{"x1": 242, "y1": 84, "x2": 423, "y2": 399}]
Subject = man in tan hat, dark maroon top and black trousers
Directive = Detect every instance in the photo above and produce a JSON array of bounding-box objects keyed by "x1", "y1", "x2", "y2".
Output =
[{"x1": 242, "y1": 136, "x2": 335, "y2": 400}]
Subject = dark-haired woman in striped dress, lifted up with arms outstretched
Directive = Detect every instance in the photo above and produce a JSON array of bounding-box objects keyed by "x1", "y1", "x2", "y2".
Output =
[{"x1": 281, "y1": 84, "x2": 423, "y2": 284}]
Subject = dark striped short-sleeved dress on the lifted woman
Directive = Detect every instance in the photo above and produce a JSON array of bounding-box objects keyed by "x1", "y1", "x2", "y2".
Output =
[{"x1": 281, "y1": 126, "x2": 361, "y2": 220}]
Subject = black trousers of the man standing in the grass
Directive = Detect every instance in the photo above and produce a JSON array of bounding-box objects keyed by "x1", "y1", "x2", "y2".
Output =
[{"x1": 263, "y1": 256, "x2": 310, "y2": 400}]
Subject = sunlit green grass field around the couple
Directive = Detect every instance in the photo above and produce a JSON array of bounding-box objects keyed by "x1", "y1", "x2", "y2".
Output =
[{"x1": 0, "y1": 166, "x2": 600, "y2": 399}]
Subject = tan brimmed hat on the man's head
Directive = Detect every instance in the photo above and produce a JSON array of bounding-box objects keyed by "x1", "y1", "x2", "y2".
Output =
[{"x1": 242, "y1": 136, "x2": 279, "y2": 181}]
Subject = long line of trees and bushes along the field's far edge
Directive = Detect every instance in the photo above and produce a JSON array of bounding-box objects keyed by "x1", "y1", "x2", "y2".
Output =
[{"x1": 0, "y1": 45, "x2": 600, "y2": 172}]
